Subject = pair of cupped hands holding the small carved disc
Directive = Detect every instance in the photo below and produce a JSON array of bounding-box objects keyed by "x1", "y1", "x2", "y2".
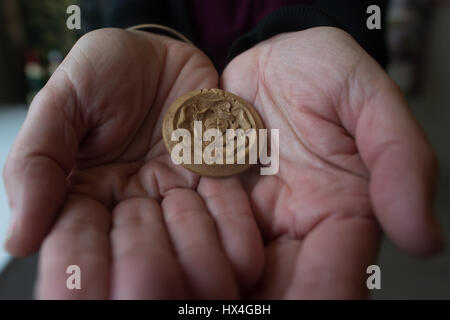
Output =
[{"x1": 4, "y1": 27, "x2": 442, "y2": 299}]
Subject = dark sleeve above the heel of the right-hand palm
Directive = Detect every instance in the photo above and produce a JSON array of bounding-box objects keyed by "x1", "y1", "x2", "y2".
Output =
[{"x1": 227, "y1": 0, "x2": 388, "y2": 67}]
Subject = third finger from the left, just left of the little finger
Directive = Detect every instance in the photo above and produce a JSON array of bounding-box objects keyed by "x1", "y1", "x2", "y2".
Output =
[{"x1": 162, "y1": 189, "x2": 238, "y2": 299}]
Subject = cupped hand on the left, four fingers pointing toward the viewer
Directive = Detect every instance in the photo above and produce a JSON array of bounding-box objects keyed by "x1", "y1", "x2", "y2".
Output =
[{"x1": 4, "y1": 30, "x2": 262, "y2": 299}]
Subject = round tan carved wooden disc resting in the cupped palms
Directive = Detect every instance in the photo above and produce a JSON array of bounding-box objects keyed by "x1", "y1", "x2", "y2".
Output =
[{"x1": 162, "y1": 89, "x2": 264, "y2": 177}]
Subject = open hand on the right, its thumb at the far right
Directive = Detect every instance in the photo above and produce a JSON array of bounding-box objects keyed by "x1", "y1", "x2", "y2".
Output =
[{"x1": 221, "y1": 28, "x2": 442, "y2": 298}]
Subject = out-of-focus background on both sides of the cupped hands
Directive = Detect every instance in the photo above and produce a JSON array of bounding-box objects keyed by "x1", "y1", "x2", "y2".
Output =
[{"x1": 0, "y1": 0, "x2": 450, "y2": 299}]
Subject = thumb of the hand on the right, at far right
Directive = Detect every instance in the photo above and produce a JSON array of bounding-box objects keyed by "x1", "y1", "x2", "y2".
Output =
[{"x1": 356, "y1": 81, "x2": 442, "y2": 255}]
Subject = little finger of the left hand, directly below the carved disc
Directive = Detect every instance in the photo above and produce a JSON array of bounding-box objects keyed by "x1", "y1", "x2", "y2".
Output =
[{"x1": 198, "y1": 177, "x2": 264, "y2": 292}]
